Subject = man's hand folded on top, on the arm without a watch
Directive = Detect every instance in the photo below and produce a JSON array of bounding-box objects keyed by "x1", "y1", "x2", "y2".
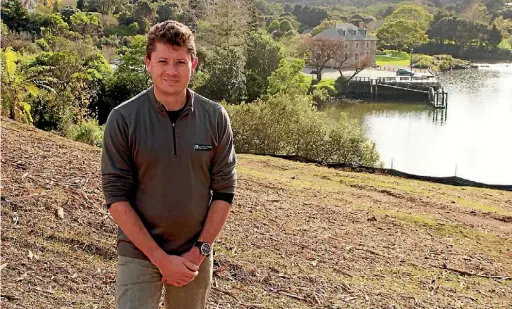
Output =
[{"x1": 155, "y1": 255, "x2": 199, "y2": 287}]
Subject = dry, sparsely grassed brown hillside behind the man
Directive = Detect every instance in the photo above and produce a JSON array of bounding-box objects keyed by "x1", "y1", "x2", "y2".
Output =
[{"x1": 1, "y1": 118, "x2": 512, "y2": 308}]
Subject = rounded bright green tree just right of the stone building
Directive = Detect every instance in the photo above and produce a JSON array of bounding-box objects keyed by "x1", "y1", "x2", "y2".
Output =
[{"x1": 377, "y1": 20, "x2": 428, "y2": 50}]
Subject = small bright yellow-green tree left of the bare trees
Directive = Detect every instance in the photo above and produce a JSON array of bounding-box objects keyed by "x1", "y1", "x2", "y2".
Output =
[{"x1": 267, "y1": 59, "x2": 309, "y2": 96}]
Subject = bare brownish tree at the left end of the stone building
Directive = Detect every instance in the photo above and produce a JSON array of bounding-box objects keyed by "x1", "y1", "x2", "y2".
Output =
[{"x1": 306, "y1": 38, "x2": 343, "y2": 80}]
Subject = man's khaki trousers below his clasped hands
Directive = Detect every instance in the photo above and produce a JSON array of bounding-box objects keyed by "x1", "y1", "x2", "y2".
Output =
[{"x1": 116, "y1": 255, "x2": 213, "y2": 309}]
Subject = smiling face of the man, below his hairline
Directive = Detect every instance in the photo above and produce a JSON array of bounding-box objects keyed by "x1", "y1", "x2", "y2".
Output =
[{"x1": 145, "y1": 42, "x2": 197, "y2": 95}]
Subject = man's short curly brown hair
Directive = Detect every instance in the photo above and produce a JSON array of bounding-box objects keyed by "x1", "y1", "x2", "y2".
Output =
[{"x1": 146, "y1": 20, "x2": 196, "y2": 59}]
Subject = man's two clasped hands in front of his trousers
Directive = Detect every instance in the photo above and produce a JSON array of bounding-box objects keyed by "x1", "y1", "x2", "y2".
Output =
[{"x1": 156, "y1": 247, "x2": 205, "y2": 287}]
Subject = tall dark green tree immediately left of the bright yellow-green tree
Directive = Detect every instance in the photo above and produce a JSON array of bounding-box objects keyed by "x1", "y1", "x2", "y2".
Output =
[{"x1": 245, "y1": 32, "x2": 283, "y2": 102}]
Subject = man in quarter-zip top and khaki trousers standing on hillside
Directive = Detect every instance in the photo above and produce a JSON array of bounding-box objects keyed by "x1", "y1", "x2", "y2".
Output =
[{"x1": 101, "y1": 21, "x2": 236, "y2": 309}]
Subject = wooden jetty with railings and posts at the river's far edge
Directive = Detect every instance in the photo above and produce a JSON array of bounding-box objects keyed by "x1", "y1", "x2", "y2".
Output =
[{"x1": 351, "y1": 75, "x2": 448, "y2": 109}]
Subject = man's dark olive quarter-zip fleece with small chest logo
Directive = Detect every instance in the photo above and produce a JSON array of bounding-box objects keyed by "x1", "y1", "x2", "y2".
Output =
[{"x1": 101, "y1": 87, "x2": 236, "y2": 260}]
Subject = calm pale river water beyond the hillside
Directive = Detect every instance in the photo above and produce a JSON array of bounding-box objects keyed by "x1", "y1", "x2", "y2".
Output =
[{"x1": 327, "y1": 64, "x2": 512, "y2": 184}]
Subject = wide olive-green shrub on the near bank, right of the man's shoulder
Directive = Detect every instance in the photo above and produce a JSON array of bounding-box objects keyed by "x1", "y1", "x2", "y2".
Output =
[{"x1": 225, "y1": 93, "x2": 380, "y2": 166}]
